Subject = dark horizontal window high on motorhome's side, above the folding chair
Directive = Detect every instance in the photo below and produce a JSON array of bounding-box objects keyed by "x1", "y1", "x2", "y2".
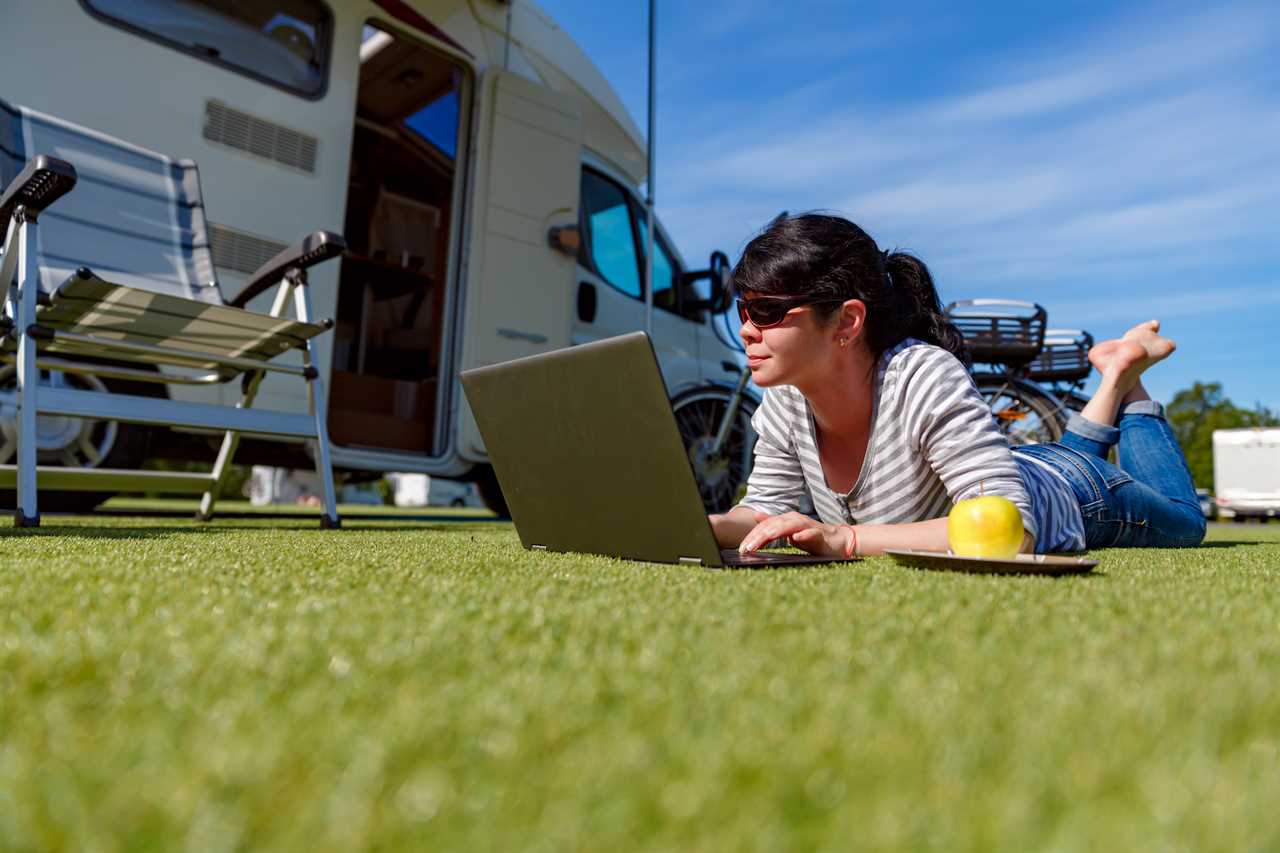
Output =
[{"x1": 81, "y1": 0, "x2": 333, "y2": 97}]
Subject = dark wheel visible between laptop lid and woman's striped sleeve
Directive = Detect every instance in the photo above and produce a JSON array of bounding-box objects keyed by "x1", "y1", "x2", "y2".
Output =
[{"x1": 672, "y1": 387, "x2": 756, "y2": 512}]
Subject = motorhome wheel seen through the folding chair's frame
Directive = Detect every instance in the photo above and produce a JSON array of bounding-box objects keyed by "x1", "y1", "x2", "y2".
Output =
[{"x1": 0, "y1": 365, "x2": 160, "y2": 512}]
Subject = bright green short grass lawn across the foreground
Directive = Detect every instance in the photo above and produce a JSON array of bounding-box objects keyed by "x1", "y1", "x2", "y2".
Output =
[{"x1": 0, "y1": 507, "x2": 1280, "y2": 853}]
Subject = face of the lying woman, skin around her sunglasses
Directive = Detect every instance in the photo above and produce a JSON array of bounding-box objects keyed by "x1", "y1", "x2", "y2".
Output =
[{"x1": 739, "y1": 293, "x2": 841, "y2": 388}]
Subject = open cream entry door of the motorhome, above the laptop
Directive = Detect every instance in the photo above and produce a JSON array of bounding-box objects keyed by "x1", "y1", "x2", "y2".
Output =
[{"x1": 458, "y1": 70, "x2": 582, "y2": 459}]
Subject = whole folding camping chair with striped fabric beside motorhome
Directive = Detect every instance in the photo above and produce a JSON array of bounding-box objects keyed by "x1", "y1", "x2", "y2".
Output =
[{"x1": 0, "y1": 101, "x2": 346, "y2": 528}]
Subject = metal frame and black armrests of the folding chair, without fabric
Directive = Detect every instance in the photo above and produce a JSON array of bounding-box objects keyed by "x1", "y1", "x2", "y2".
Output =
[{"x1": 0, "y1": 156, "x2": 346, "y2": 529}]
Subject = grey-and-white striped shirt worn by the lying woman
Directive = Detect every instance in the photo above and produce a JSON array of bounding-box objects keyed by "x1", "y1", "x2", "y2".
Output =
[{"x1": 741, "y1": 338, "x2": 1084, "y2": 553}]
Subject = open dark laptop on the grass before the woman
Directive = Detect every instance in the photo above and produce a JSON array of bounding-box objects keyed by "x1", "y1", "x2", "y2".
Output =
[{"x1": 462, "y1": 332, "x2": 836, "y2": 569}]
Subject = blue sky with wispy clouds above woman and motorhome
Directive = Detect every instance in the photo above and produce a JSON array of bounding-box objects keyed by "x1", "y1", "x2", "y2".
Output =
[{"x1": 541, "y1": 0, "x2": 1280, "y2": 411}]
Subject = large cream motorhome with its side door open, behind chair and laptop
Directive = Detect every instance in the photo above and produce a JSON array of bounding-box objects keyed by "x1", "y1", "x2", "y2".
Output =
[{"x1": 0, "y1": 0, "x2": 754, "y2": 508}]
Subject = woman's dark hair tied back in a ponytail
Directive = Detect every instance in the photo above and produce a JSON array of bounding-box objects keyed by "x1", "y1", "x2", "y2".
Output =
[{"x1": 733, "y1": 213, "x2": 969, "y2": 365}]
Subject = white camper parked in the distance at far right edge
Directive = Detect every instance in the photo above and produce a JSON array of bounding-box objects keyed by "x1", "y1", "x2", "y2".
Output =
[{"x1": 1213, "y1": 428, "x2": 1280, "y2": 519}]
